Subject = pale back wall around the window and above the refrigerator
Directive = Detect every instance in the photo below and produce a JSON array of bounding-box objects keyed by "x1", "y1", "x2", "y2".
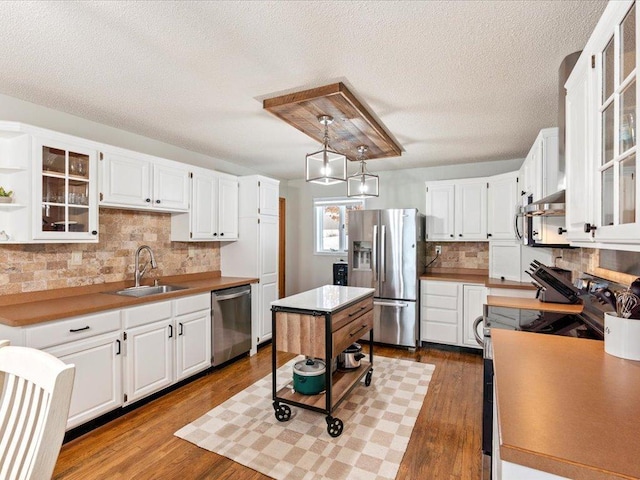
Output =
[{"x1": 286, "y1": 158, "x2": 523, "y2": 295}]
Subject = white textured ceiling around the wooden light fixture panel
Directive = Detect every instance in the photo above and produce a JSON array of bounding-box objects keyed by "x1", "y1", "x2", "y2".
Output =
[{"x1": 0, "y1": 0, "x2": 606, "y2": 179}]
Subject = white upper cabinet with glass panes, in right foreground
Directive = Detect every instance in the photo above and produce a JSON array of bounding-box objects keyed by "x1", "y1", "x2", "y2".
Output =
[{"x1": 565, "y1": 0, "x2": 640, "y2": 251}]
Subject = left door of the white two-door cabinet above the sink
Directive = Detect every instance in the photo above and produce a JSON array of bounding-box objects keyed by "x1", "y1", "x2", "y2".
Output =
[{"x1": 100, "y1": 152, "x2": 151, "y2": 207}]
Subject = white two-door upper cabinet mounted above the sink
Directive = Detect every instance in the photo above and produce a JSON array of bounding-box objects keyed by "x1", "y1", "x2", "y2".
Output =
[{"x1": 100, "y1": 151, "x2": 190, "y2": 212}]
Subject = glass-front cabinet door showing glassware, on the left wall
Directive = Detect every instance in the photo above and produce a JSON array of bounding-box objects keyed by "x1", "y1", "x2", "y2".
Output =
[{"x1": 33, "y1": 138, "x2": 98, "y2": 241}]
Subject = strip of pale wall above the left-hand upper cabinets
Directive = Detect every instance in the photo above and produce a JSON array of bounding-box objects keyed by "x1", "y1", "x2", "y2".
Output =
[{"x1": 0, "y1": 94, "x2": 259, "y2": 175}]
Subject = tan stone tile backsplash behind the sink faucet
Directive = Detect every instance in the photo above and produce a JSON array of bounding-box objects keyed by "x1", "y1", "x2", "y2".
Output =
[{"x1": 0, "y1": 209, "x2": 220, "y2": 295}]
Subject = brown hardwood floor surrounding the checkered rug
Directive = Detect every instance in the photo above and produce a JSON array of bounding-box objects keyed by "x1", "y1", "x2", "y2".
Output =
[{"x1": 54, "y1": 346, "x2": 482, "y2": 480}]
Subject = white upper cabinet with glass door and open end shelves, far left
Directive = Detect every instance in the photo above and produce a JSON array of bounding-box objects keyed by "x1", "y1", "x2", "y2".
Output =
[{"x1": 0, "y1": 122, "x2": 98, "y2": 243}]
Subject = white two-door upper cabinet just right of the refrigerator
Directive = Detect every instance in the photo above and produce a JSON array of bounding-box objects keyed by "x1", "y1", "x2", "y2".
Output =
[{"x1": 425, "y1": 178, "x2": 487, "y2": 242}]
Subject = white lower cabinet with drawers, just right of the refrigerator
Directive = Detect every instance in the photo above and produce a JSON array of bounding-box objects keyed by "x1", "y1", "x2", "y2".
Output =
[{"x1": 420, "y1": 280, "x2": 486, "y2": 348}]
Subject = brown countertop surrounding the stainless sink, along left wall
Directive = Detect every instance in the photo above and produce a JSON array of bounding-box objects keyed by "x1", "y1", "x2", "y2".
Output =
[{"x1": 0, "y1": 271, "x2": 258, "y2": 327}]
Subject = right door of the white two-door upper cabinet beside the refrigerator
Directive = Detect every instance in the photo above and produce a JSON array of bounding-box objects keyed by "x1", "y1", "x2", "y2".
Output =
[{"x1": 455, "y1": 178, "x2": 487, "y2": 242}]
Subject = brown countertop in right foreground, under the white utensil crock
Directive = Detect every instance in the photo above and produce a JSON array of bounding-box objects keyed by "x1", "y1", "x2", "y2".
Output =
[{"x1": 491, "y1": 329, "x2": 640, "y2": 480}]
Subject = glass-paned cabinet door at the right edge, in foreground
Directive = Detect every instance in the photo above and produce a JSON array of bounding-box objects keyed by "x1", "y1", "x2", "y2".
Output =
[{"x1": 593, "y1": 2, "x2": 640, "y2": 243}]
